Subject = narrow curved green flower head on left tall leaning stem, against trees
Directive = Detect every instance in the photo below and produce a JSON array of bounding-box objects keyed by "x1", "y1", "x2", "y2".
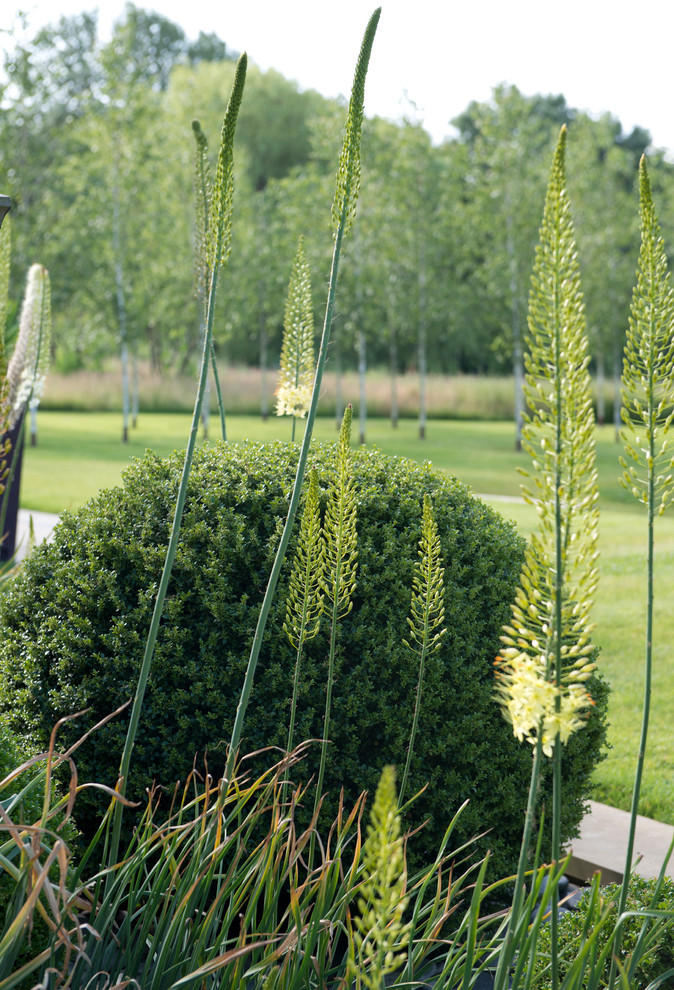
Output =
[{"x1": 208, "y1": 52, "x2": 248, "y2": 275}]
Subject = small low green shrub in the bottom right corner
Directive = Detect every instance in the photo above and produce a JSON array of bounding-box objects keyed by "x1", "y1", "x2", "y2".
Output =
[{"x1": 534, "y1": 876, "x2": 674, "y2": 990}]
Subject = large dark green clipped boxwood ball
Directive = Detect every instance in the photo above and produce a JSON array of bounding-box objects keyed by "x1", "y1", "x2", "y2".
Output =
[{"x1": 0, "y1": 443, "x2": 605, "y2": 874}]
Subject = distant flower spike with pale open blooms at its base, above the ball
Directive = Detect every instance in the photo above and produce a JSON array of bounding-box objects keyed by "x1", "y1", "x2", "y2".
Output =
[{"x1": 276, "y1": 237, "x2": 315, "y2": 433}]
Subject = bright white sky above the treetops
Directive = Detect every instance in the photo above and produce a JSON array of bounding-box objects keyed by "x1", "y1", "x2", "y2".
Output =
[{"x1": 11, "y1": 0, "x2": 674, "y2": 159}]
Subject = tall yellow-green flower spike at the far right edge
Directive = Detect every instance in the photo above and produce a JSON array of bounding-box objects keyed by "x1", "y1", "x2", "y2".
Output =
[{"x1": 620, "y1": 158, "x2": 674, "y2": 514}]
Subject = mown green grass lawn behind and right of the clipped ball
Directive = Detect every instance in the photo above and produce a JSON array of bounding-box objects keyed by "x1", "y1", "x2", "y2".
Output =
[{"x1": 15, "y1": 411, "x2": 674, "y2": 824}]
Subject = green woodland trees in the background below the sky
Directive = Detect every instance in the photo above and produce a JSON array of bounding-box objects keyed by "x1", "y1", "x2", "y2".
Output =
[{"x1": 0, "y1": 4, "x2": 674, "y2": 430}]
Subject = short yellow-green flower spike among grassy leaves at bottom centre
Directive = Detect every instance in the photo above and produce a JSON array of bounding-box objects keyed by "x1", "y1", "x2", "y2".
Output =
[{"x1": 347, "y1": 766, "x2": 411, "y2": 990}]
